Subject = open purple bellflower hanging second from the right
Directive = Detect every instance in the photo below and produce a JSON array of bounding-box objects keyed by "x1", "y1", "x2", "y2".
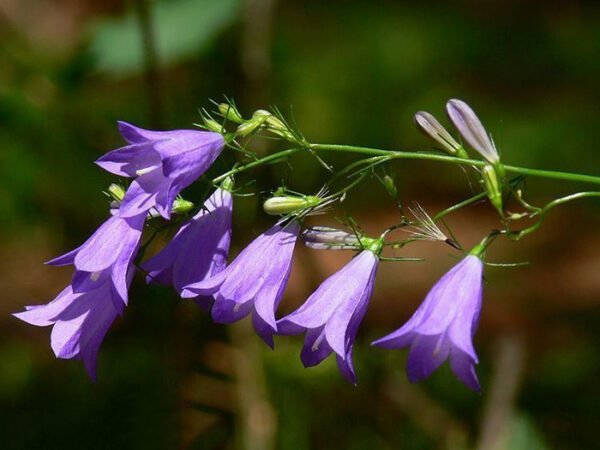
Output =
[{"x1": 277, "y1": 250, "x2": 379, "y2": 384}]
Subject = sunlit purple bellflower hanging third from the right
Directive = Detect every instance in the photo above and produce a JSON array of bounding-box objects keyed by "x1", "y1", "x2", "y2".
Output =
[{"x1": 182, "y1": 221, "x2": 300, "y2": 347}]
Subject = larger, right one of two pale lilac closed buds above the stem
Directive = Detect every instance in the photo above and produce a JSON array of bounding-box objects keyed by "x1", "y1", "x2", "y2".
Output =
[{"x1": 446, "y1": 99, "x2": 500, "y2": 164}]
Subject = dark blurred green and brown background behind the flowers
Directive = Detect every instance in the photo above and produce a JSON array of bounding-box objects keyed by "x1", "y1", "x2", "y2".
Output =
[{"x1": 0, "y1": 0, "x2": 600, "y2": 450}]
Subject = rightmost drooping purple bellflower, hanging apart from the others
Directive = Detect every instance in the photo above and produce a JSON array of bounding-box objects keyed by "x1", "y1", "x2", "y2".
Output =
[{"x1": 373, "y1": 255, "x2": 483, "y2": 391}]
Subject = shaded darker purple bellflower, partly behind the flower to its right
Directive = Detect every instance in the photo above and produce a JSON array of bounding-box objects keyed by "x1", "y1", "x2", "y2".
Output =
[{"x1": 142, "y1": 188, "x2": 233, "y2": 306}]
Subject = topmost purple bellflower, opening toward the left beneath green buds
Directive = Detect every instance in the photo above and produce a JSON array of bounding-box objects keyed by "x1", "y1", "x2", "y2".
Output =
[{"x1": 96, "y1": 122, "x2": 225, "y2": 219}]
